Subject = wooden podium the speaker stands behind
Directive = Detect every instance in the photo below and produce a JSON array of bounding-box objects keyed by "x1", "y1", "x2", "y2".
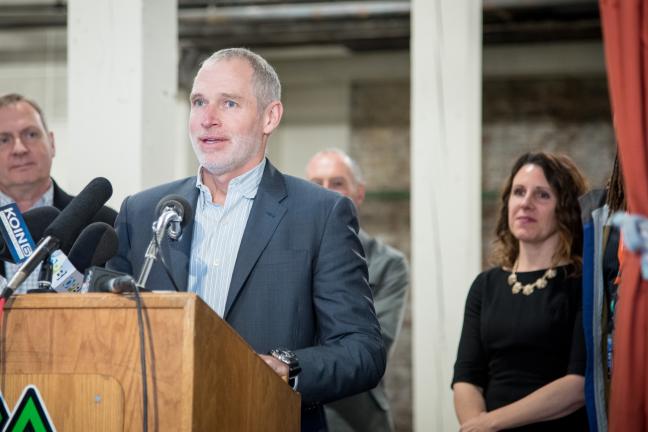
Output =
[{"x1": 0, "y1": 293, "x2": 301, "y2": 431}]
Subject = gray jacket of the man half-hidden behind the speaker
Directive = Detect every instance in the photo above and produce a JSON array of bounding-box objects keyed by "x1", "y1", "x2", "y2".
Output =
[{"x1": 326, "y1": 230, "x2": 409, "y2": 432}]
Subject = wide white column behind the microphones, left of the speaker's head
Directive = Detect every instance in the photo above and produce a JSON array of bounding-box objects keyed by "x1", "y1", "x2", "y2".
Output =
[{"x1": 65, "y1": 0, "x2": 177, "y2": 207}]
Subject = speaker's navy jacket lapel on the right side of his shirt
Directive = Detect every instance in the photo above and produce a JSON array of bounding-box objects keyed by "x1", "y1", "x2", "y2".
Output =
[{"x1": 228, "y1": 161, "x2": 286, "y2": 319}]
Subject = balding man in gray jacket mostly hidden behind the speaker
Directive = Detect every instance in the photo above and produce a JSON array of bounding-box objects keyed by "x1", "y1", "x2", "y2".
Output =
[{"x1": 306, "y1": 149, "x2": 409, "y2": 432}]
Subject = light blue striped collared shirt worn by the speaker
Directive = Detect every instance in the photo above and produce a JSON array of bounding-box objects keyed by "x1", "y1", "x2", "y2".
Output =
[{"x1": 188, "y1": 158, "x2": 266, "y2": 317}]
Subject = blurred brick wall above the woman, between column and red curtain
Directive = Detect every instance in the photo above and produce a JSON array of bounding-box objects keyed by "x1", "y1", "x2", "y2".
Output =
[{"x1": 482, "y1": 76, "x2": 615, "y2": 264}]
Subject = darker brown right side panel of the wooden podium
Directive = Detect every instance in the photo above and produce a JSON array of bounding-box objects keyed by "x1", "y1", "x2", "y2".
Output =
[{"x1": 193, "y1": 301, "x2": 301, "y2": 432}]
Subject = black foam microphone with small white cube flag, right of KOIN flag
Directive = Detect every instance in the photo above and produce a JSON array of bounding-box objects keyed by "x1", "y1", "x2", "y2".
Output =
[{"x1": 52, "y1": 222, "x2": 119, "y2": 292}]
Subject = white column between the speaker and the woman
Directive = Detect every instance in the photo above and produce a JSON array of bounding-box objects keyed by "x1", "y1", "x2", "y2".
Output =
[{"x1": 411, "y1": 0, "x2": 482, "y2": 431}]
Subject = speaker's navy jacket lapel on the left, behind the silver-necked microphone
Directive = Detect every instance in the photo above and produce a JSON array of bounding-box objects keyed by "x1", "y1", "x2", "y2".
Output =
[{"x1": 165, "y1": 177, "x2": 199, "y2": 291}]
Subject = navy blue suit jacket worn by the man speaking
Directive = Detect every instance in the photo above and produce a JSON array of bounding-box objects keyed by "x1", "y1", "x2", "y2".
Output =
[{"x1": 108, "y1": 161, "x2": 385, "y2": 430}]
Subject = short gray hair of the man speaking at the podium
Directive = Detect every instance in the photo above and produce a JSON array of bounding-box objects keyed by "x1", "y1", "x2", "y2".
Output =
[{"x1": 203, "y1": 48, "x2": 281, "y2": 109}]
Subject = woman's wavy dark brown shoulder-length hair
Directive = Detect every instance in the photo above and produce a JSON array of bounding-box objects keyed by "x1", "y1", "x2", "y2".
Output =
[{"x1": 491, "y1": 152, "x2": 587, "y2": 270}]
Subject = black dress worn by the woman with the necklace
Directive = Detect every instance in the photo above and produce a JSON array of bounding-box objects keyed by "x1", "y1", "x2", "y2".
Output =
[{"x1": 452, "y1": 266, "x2": 588, "y2": 432}]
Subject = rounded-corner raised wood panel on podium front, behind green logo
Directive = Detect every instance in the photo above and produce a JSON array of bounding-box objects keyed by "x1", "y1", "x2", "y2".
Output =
[{"x1": 2, "y1": 374, "x2": 124, "y2": 432}]
